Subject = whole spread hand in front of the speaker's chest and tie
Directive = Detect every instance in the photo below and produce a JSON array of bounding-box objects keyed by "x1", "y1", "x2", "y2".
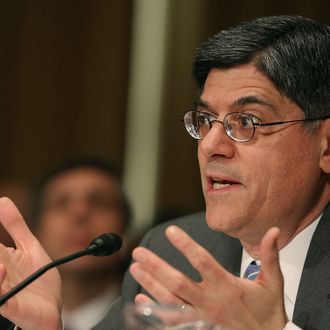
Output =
[{"x1": 130, "y1": 226, "x2": 287, "y2": 330}]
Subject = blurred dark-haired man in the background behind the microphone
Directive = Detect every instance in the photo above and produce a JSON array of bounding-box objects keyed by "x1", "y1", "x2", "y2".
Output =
[{"x1": 34, "y1": 157, "x2": 130, "y2": 330}]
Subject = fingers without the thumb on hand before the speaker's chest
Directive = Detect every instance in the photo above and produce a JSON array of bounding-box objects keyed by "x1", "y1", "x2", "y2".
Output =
[{"x1": 130, "y1": 226, "x2": 235, "y2": 305}]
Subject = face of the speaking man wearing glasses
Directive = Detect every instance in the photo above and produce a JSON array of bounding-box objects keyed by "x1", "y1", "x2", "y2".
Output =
[{"x1": 198, "y1": 65, "x2": 323, "y2": 244}]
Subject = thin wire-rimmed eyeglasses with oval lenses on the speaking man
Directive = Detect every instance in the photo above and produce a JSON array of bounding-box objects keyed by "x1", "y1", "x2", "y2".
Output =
[{"x1": 183, "y1": 110, "x2": 329, "y2": 142}]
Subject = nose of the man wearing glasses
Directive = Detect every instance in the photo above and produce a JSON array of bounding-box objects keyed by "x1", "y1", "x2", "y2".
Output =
[{"x1": 198, "y1": 121, "x2": 235, "y2": 158}]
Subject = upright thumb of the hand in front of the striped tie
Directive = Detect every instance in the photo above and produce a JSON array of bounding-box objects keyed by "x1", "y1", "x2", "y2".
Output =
[{"x1": 260, "y1": 227, "x2": 283, "y2": 289}]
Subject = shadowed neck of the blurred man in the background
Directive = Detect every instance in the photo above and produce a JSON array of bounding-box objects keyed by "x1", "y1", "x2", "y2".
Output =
[{"x1": 61, "y1": 273, "x2": 121, "y2": 311}]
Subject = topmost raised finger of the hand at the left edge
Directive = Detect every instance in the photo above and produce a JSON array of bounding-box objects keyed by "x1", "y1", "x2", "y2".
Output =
[{"x1": 0, "y1": 197, "x2": 36, "y2": 250}]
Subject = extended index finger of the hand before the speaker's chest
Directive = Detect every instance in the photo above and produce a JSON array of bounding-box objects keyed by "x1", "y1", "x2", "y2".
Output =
[{"x1": 166, "y1": 226, "x2": 228, "y2": 282}]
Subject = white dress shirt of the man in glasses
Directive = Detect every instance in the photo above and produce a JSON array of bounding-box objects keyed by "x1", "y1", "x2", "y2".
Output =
[{"x1": 241, "y1": 215, "x2": 321, "y2": 330}]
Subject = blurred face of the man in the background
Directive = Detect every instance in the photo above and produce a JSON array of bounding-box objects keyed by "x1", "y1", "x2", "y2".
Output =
[{"x1": 38, "y1": 168, "x2": 124, "y2": 271}]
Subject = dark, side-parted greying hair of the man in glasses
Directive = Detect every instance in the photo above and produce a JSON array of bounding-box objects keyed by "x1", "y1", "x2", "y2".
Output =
[{"x1": 193, "y1": 15, "x2": 330, "y2": 118}]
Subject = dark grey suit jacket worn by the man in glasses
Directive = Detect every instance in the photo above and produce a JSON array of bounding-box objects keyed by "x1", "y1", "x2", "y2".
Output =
[{"x1": 93, "y1": 207, "x2": 330, "y2": 330}]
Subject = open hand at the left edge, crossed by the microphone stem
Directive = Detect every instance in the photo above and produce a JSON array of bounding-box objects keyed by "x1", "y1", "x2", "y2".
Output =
[{"x1": 0, "y1": 198, "x2": 61, "y2": 330}]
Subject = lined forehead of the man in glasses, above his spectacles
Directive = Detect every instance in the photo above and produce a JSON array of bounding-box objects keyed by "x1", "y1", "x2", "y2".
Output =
[{"x1": 200, "y1": 64, "x2": 301, "y2": 116}]
